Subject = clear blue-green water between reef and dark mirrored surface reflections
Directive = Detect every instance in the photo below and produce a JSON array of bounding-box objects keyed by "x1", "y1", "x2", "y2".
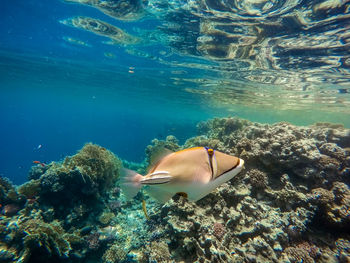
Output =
[{"x1": 0, "y1": 0, "x2": 350, "y2": 184}]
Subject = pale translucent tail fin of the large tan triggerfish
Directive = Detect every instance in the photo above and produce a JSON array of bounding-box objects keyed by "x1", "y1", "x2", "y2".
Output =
[{"x1": 120, "y1": 168, "x2": 143, "y2": 200}]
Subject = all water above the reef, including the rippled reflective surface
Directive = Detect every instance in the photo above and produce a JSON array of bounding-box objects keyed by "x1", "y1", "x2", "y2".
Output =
[{"x1": 0, "y1": 1, "x2": 350, "y2": 186}]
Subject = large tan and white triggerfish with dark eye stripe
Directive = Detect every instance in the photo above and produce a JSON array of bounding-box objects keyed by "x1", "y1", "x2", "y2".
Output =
[{"x1": 120, "y1": 147, "x2": 244, "y2": 203}]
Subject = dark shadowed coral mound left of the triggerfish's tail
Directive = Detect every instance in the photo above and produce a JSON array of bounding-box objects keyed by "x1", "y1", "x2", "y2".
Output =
[{"x1": 0, "y1": 143, "x2": 121, "y2": 262}]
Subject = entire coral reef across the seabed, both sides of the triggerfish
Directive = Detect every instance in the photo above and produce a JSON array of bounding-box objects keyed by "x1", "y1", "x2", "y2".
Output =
[{"x1": 0, "y1": 118, "x2": 350, "y2": 263}]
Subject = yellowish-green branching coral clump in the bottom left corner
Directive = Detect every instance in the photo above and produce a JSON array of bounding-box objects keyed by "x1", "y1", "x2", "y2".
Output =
[{"x1": 0, "y1": 209, "x2": 82, "y2": 262}]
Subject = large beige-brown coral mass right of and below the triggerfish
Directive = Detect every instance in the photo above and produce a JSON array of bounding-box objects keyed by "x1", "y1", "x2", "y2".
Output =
[{"x1": 137, "y1": 118, "x2": 350, "y2": 262}]
